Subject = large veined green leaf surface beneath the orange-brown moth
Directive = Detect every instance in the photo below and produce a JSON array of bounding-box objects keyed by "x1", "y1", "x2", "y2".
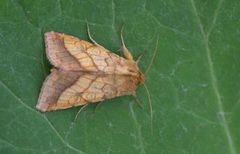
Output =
[{"x1": 0, "y1": 0, "x2": 240, "y2": 154}]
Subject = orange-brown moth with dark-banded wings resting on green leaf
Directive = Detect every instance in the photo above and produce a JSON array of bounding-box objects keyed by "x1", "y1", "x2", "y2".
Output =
[{"x1": 36, "y1": 29, "x2": 144, "y2": 112}]
